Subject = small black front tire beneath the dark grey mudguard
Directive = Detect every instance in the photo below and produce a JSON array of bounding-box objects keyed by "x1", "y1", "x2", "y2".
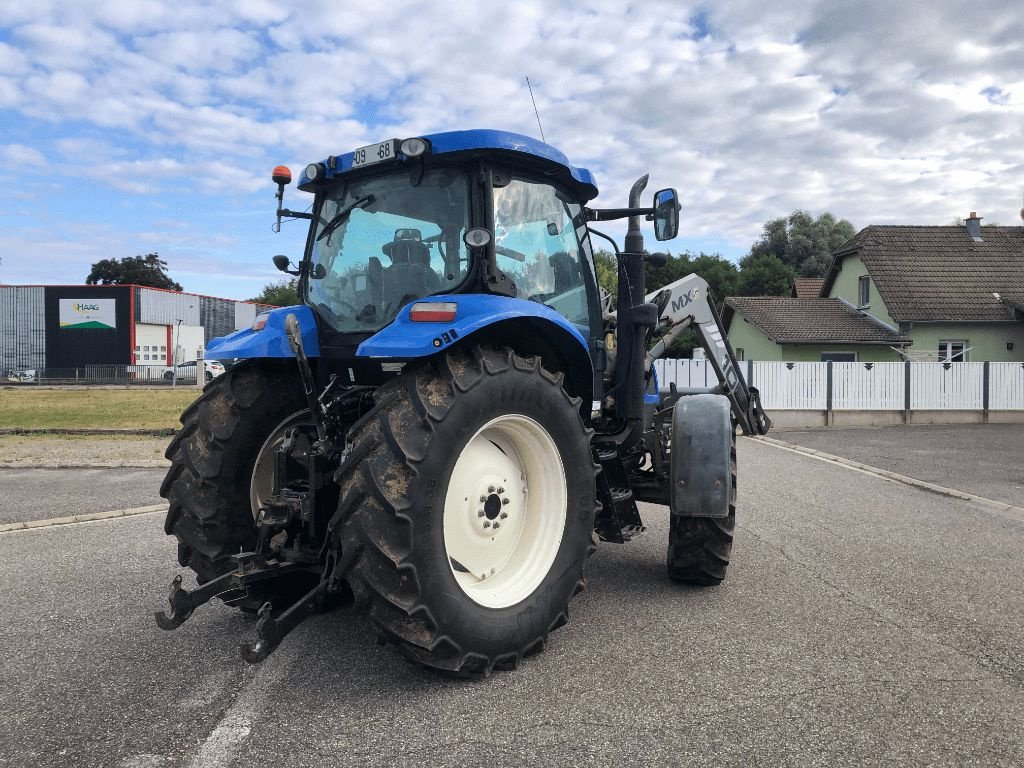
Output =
[{"x1": 668, "y1": 434, "x2": 736, "y2": 587}]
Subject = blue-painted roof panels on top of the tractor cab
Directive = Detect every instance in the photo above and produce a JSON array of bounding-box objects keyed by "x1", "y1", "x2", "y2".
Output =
[{"x1": 299, "y1": 128, "x2": 598, "y2": 203}]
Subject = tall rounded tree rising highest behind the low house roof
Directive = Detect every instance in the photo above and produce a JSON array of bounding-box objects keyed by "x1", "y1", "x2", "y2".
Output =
[{"x1": 750, "y1": 211, "x2": 854, "y2": 278}]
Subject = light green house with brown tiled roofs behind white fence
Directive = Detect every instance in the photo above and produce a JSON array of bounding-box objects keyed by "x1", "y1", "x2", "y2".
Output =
[{"x1": 723, "y1": 212, "x2": 1024, "y2": 362}]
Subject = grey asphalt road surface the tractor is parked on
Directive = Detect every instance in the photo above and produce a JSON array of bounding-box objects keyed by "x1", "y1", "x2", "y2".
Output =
[{"x1": 0, "y1": 433, "x2": 1024, "y2": 768}]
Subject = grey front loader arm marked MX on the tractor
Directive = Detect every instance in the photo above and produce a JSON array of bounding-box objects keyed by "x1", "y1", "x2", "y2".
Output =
[{"x1": 645, "y1": 274, "x2": 771, "y2": 434}]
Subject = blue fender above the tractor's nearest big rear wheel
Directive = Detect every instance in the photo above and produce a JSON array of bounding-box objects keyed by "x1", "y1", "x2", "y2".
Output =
[{"x1": 355, "y1": 294, "x2": 589, "y2": 359}]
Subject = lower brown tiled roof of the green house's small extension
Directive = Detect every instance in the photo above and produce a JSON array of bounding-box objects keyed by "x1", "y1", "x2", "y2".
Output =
[{"x1": 723, "y1": 296, "x2": 911, "y2": 346}]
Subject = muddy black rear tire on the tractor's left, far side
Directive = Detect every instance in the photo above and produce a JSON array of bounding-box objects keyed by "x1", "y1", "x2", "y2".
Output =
[{"x1": 160, "y1": 364, "x2": 306, "y2": 584}]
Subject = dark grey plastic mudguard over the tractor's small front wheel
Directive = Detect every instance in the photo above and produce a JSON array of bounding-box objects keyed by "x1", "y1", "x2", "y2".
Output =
[{"x1": 670, "y1": 394, "x2": 735, "y2": 517}]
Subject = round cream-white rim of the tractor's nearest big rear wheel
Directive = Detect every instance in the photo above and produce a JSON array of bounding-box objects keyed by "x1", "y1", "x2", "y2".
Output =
[{"x1": 444, "y1": 414, "x2": 567, "y2": 608}]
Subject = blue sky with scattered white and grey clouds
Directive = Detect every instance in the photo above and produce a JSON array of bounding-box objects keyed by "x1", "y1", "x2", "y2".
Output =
[{"x1": 0, "y1": 0, "x2": 1024, "y2": 299}]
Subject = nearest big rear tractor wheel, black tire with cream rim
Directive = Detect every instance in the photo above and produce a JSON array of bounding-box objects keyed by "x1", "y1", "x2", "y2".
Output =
[{"x1": 336, "y1": 349, "x2": 596, "y2": 675}]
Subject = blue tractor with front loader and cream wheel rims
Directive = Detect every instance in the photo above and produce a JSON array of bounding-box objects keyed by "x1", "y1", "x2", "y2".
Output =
[{"x1": 157, "y1": 130, "x2": 769, "y2": 675}]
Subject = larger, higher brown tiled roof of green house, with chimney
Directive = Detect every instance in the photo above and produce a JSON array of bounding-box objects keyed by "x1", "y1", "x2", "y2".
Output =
[{"x1": 823, "y1": 225, "x2": 1024, "y2": 322}]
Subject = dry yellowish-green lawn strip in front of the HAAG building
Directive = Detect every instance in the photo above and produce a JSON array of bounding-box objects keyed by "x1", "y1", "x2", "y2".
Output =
[{"x1": 0, "y1": 387, "x2": 200, "y2": 429}]
